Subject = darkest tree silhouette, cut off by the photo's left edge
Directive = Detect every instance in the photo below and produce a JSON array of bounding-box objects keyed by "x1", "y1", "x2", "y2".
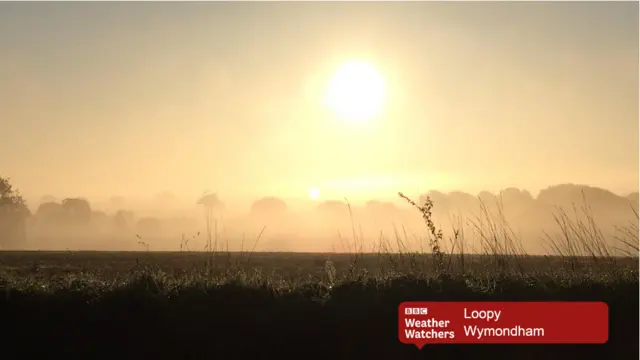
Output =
[{"x1": 0, "y1": 177, "x2": 30, "y2": 249}]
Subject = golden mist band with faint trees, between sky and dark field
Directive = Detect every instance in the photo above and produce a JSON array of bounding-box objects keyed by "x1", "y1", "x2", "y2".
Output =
[{"x1": 18, "y1": 184, "x2": 638, "y2": 254}]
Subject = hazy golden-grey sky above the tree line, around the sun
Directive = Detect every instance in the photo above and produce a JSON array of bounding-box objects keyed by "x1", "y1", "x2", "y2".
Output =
[{"x1": 0, "y1": 2, "x2": 638, "y2": 198}]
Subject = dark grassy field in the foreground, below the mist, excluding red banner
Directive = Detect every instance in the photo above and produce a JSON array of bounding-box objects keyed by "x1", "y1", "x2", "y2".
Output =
[{"x1": 0, "y1": 253, "x2": 639, "y2": 360}]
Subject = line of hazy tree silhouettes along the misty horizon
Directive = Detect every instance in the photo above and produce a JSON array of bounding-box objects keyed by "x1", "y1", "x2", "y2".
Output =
[{"x1": 0, "y1": 177, "x2": 638, "y2": 249}]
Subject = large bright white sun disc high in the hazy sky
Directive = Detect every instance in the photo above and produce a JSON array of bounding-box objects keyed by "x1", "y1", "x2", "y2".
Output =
[{"x1": 325, "y1": 61, "x2": 386, "y2": 122}]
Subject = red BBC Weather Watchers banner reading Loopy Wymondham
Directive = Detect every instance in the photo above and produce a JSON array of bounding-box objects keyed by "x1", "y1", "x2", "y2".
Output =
[{"x1": 398, "y1": 302, "x2": 609, "y2": 348}]
